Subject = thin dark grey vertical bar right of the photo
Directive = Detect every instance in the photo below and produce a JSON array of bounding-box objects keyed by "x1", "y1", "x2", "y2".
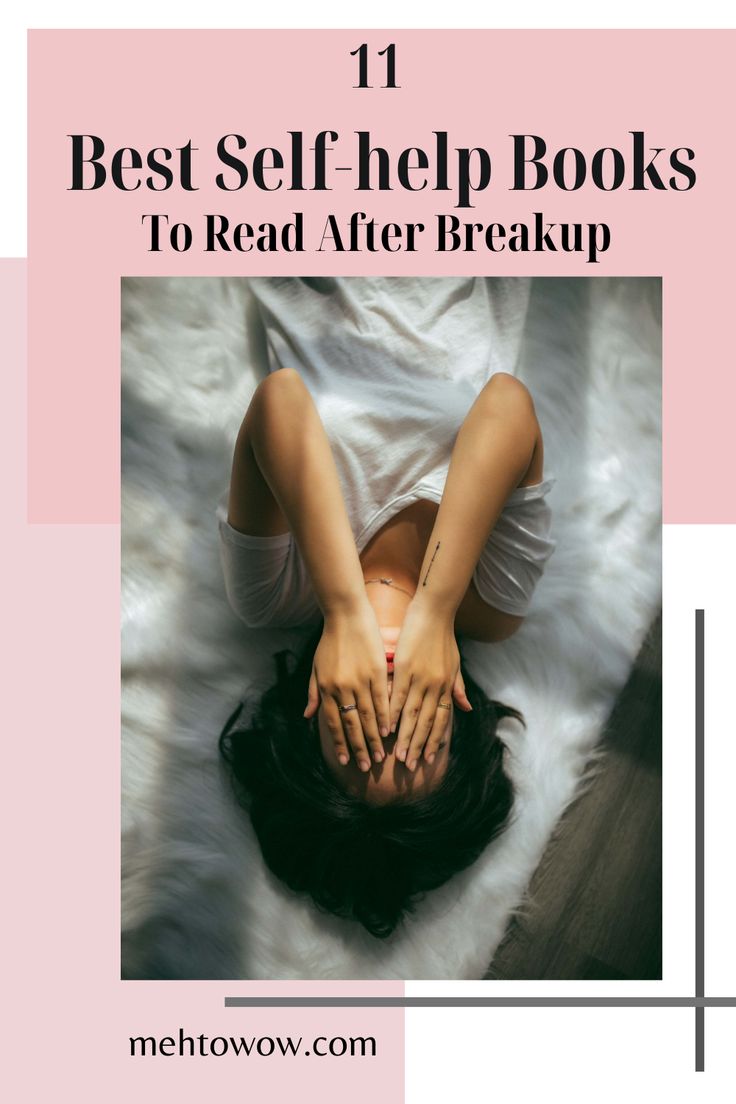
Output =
[{"x1": 695, "y1": 609, "x2": 705, "y2": 1073}]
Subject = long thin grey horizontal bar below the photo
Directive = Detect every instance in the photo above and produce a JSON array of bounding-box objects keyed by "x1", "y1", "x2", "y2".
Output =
[{"x1": 225, "y1": 997, "x2": 736, "y2": 1008}]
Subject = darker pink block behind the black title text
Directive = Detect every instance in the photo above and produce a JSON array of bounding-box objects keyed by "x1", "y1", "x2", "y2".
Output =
[{"x1": 29, "y1": 31, "x2": 736, "y2": 522}]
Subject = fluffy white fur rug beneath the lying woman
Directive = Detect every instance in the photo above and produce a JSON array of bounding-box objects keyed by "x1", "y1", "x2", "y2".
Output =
[{"x1": 122, "y1": 278, "x2": 661, "y2": 978}]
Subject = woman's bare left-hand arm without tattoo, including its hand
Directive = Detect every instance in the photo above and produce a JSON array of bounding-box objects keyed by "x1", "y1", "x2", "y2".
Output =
[{"x1": 228, "y1": 369, "x2": 388, "y2": 771}]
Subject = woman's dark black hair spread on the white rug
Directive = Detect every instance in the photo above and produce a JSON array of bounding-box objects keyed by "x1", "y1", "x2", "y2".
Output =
[{"x1": 220, "y1": 641, "x2": 522, "y2": 938}]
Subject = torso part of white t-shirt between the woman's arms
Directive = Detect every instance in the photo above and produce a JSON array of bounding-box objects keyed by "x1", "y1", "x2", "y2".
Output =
[{"x1": 249, "y1": 276, "x2": 530, "y2": 552}]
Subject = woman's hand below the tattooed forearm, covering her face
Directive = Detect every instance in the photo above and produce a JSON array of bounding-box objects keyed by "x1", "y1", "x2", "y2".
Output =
[{"x1": 391, "y1": 604, "x2": 472, "y2": 771}]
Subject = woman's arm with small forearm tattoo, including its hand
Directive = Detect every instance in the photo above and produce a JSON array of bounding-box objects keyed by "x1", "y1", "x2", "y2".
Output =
[{"x1": 391, "y1": 373, "x2": 542, "y2": 769}]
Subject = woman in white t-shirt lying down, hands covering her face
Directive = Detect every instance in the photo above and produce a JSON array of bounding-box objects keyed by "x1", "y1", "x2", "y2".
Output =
[{"x1": 218, "y1": 278, "x2": 554, "y2": 935}]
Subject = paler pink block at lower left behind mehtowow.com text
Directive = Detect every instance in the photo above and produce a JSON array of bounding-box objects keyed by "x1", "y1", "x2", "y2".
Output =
[{"x1": 0, "y1": 261, "x2": 404, "y2": 1104}]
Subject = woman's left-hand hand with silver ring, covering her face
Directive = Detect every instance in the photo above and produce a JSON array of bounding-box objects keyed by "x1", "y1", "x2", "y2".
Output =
[{"x1": 305, "y1": 598, "x2": 390, "y2": 771}]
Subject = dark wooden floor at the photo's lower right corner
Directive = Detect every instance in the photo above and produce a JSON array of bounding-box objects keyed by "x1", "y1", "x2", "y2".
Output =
[{"x1": 486, "y1": 617, "x2": 662, "y2": 979}]
